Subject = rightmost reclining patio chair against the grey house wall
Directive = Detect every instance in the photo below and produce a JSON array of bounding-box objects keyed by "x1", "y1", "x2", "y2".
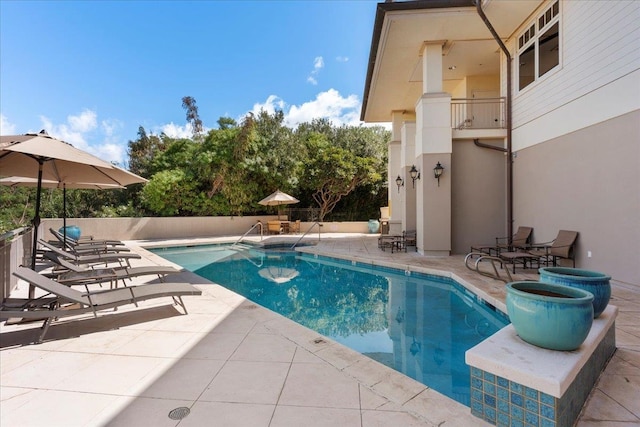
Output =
[{"x1": 499, "y1": 230, "x2": 578, "y2": 273}]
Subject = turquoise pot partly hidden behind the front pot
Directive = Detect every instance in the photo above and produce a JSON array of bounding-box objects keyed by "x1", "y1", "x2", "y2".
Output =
[{"x1": 538, "y1": 267, "x2": 611, "y2": 318}]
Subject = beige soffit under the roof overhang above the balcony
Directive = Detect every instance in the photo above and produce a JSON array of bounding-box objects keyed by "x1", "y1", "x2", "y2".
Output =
[{"x1": 362, "y1": 0, "x2": 541, "y2": 122}]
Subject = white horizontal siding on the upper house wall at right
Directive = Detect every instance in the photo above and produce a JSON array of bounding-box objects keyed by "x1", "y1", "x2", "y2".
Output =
[{"x1": 511, "y1": 0, "x2": 640, "y2": 134}]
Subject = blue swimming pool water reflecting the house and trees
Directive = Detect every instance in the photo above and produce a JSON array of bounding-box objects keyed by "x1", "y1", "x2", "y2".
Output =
[{"x1": 153, "y1": 245, "x2": 508, "y2": 406}]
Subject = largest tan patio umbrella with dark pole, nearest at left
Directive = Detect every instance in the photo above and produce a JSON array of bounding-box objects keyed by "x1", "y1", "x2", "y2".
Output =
[{"x1": 0, "y1": 130, "x2": 147, "y2": 274}]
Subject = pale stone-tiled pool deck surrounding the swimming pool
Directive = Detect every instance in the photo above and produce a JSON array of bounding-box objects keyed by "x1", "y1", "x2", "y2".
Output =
[{"x1": 0, "y1": 234, "x2": 640, "y2": 427}]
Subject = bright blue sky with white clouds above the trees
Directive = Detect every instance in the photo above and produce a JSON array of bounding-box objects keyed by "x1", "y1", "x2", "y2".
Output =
[{"x1": 0, "y1": 0, "x2": 377, "y2": 165}]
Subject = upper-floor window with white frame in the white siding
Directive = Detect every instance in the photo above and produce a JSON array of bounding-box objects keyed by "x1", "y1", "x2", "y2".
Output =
[{"x1": 518, "y1": 1, "x2": 560, "y2": 89}]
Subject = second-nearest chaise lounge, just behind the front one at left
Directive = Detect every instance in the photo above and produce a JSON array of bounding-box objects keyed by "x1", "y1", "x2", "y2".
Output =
[{"x1": 44, "y1": 252, "x2": 180, "y2": 288}]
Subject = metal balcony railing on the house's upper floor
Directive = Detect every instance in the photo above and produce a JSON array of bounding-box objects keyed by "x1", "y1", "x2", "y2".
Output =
[{"x1": 451, "y1": 98, "x2": 507, "y2": 130}]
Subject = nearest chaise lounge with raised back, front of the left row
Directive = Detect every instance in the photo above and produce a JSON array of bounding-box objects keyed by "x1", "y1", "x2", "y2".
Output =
[{"x1": 0, "y1": 267, "x2": 202, "y2": 342}]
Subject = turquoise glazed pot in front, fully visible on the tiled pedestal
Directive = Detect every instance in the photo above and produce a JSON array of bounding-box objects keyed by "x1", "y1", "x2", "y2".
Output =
[{"x1": 507, "y1": 282, "x2": 593, "y2": 351}]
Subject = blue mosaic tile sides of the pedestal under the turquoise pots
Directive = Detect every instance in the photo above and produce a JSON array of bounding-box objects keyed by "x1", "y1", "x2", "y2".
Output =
[{"x1": 471, "y1": 323, "x2": 616, "y2": 427}]
